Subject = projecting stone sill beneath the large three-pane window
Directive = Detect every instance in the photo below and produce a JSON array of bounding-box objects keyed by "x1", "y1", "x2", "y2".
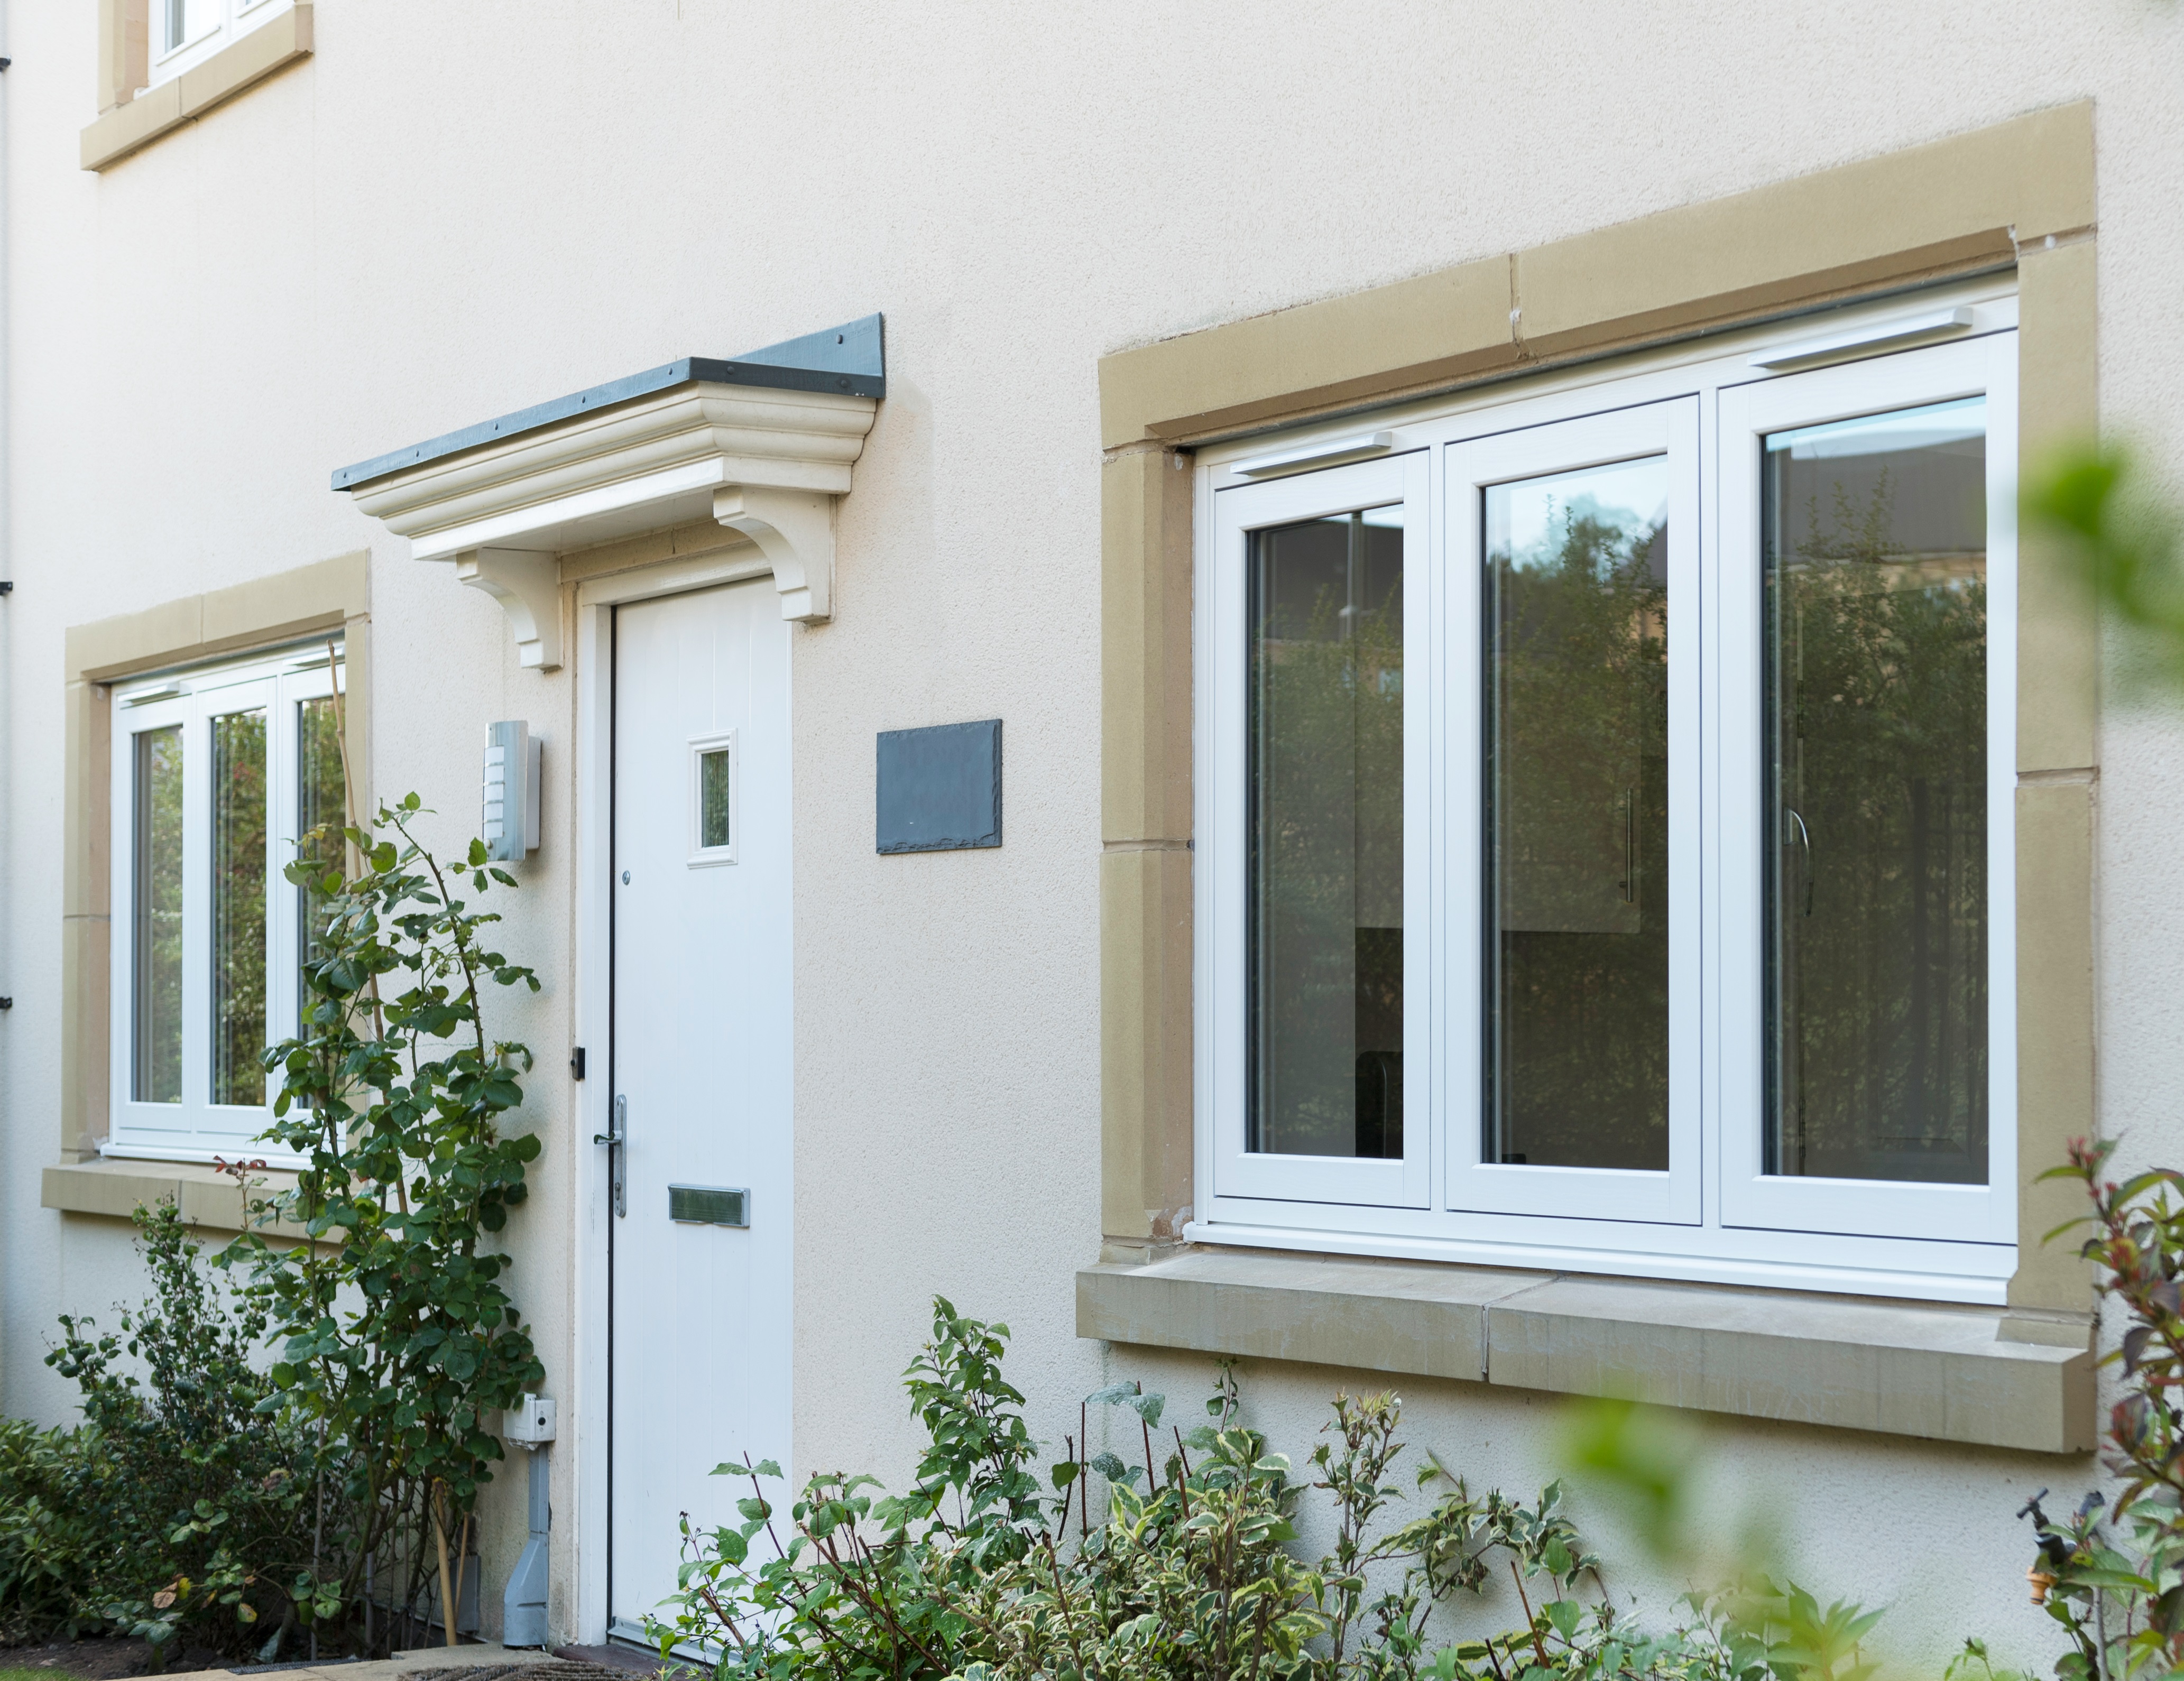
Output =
[{"x1": 1077, "y1": 1249, "x2": 2097, "y2": 1454}]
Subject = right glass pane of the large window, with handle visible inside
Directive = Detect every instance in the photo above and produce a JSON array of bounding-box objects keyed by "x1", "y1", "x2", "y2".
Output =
[{"x1": 1763, "y1": 398, "x2": 1987, "y2": 1186}]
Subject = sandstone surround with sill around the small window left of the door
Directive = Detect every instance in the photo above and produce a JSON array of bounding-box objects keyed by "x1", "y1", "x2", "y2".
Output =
[{"x1": 39, "y1": 550, "x2": 371, "y2": 1231}]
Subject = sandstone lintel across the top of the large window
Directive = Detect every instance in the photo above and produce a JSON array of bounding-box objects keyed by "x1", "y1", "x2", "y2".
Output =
[{"x1": 1101, "y1": 100, "x2": 2095, "y2": 450}]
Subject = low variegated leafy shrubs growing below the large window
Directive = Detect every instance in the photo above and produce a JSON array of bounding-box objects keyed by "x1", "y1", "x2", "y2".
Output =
[{"x1": 649, "y1": 1299, "x2": 1878, "y2": 1681}]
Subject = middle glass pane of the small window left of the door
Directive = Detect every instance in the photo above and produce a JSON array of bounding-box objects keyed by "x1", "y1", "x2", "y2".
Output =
[{"x1": 212, "y1": 707, "x2": 266, "y2": 1105}]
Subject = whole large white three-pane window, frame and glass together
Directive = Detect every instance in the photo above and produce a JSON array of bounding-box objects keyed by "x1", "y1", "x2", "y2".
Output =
[{"x1": 1190, "y1": 284, "x2": 2018, "y2": 1301}]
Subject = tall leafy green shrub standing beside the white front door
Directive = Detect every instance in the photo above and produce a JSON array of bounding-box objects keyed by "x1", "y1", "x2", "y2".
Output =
[{"x1": 220, "y1": 795, "x2": 546, "y2": 1650}]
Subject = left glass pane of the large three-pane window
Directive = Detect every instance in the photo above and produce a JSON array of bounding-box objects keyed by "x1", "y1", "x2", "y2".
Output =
[{"x1": 1247, "y1": 509, "x2": 1402, "y2": 1157}]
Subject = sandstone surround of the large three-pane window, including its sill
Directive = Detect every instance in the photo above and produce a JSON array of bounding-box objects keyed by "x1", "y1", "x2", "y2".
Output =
[{"x1": 1077, "y1": 103, "x2": 2099, "y2": 1452}]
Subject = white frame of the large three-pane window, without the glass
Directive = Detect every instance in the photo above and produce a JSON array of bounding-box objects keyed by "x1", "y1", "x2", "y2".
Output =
[{"x1": 1186, "y1": 277, "x2": 2018, "y2": 1304}]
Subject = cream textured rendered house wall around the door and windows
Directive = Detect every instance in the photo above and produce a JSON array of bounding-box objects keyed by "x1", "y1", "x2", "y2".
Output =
[{"x1": 0, "y1": 0, "x2": 2184, "y2": 1668}]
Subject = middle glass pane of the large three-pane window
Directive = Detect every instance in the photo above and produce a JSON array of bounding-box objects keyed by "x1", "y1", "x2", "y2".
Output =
[{"x1": 1485, "y1": 456, "x2": 1669, "y2": 1170}]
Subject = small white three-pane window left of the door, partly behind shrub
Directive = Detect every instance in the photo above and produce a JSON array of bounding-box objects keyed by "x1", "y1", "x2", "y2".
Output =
[{"x1": 105, "y1": 642, "x2": 343, "y2": 1161}]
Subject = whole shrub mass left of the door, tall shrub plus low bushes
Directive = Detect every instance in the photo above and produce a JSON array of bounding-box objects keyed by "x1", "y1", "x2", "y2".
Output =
[{"x1": 0, "y1": 795, "x2": 544, "y2": 1661}]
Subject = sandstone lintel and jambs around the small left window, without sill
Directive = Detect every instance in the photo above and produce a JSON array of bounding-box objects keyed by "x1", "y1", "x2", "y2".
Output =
[{"x1": 48, "y1": 550, "x2": 371, "y2": 1170}]
